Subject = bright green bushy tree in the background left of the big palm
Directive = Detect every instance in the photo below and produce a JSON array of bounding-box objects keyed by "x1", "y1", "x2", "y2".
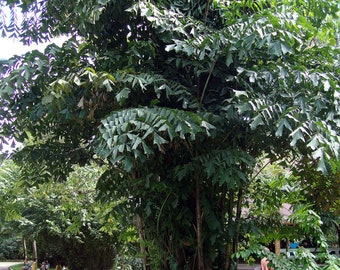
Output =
[{"x1": 1, "y1": 162, "x2": 133, "y2": 269}]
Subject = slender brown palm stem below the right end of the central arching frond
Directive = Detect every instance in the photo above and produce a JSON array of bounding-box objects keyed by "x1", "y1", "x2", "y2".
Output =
[{"x1": 195, "y1": 174, "x2": 204, "y2": 270}]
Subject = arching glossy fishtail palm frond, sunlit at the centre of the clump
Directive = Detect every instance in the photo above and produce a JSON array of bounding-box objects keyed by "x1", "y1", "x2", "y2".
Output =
[{"x1": 97, "y1": 107, "x2": 214, "y2": 170}]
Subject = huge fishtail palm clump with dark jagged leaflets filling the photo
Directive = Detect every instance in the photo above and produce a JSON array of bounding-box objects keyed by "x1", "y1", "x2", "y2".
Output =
[{"x1": 0, "y1": 0, "x2": 339, "y2": 269}]
